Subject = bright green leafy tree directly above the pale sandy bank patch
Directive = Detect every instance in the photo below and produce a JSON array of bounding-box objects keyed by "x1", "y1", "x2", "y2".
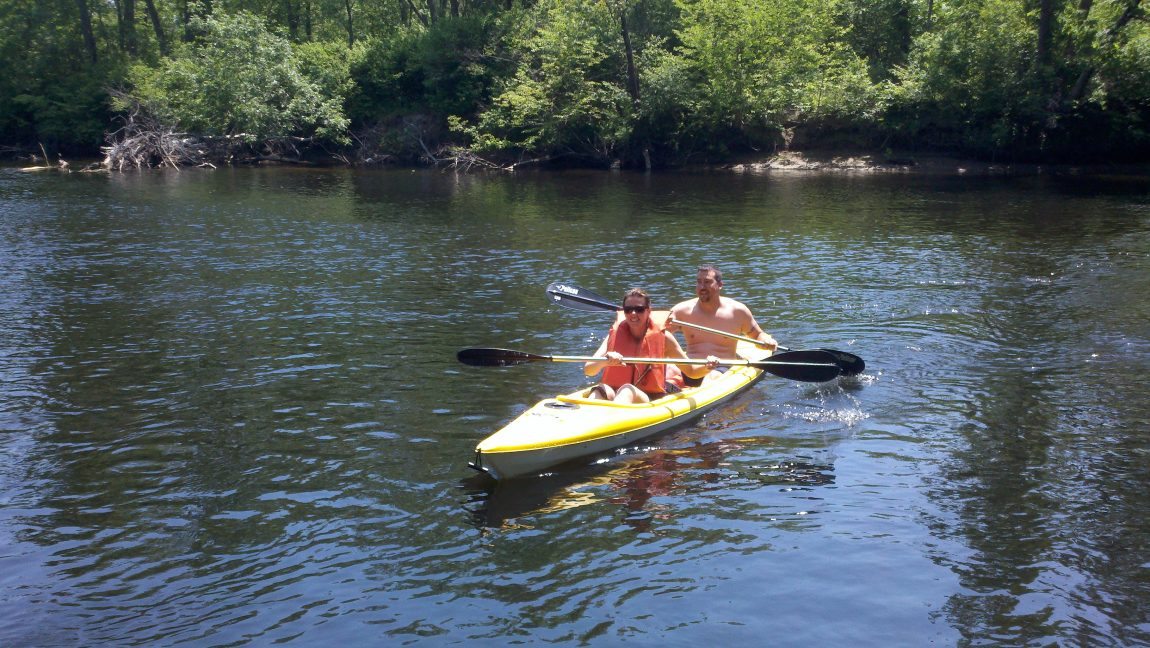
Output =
[{"x1": 679, "y1": 0, "x2": 882, "y2": 144}]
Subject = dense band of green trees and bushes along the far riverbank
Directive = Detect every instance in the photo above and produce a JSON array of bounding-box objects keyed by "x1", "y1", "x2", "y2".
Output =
[{"x1": 0, "y1": 0, "x2": 1150, "y2": 167}]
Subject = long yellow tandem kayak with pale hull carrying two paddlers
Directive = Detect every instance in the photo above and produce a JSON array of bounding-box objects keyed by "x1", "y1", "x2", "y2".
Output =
[{"x1": 469, "y1": 343, "x2": 771, "y2": 479}]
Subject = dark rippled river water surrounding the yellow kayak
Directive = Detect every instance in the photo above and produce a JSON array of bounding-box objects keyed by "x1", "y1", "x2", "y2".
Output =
[{"x1": 0, "y1": 169, "x2": 1150, "y2": 647}]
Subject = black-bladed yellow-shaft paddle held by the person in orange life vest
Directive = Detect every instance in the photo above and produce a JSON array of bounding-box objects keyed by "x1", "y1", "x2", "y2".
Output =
[{"x1": 455, "y1": 346, "x2": 842, "y2": 382}]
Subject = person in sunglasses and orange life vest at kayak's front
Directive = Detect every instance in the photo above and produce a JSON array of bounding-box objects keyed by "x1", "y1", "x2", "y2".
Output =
[{"x1": 583, "y1": 288, "x2": 719, "y2": 403}]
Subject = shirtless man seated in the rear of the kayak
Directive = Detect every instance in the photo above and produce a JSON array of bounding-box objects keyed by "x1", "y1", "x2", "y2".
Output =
[{"x1": 667, "y1": 265, "x2": 779, "y2": 387}]
